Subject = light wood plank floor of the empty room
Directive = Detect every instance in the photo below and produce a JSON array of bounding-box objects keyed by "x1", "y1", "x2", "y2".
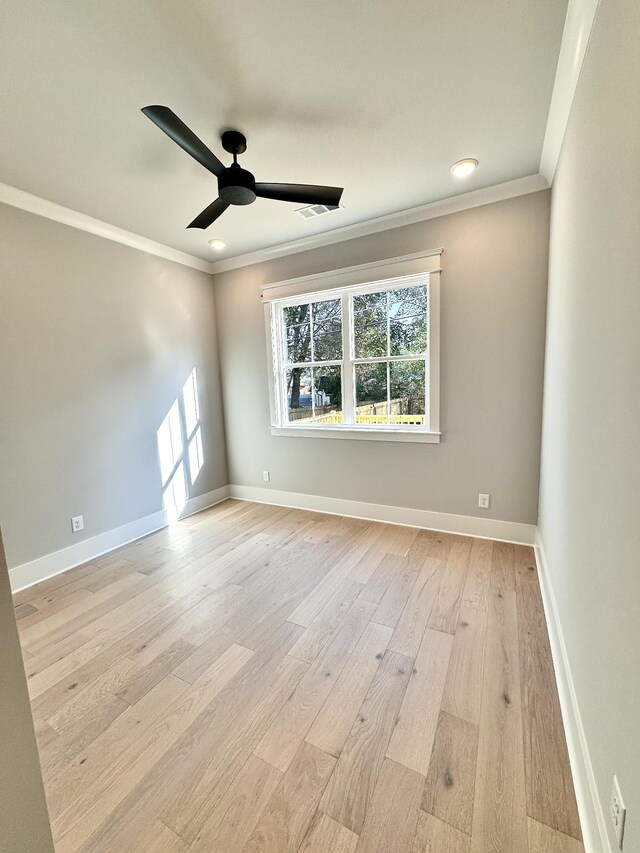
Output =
[{"x1": 16, "y1": 501, "x2": 583, "y2": 853}]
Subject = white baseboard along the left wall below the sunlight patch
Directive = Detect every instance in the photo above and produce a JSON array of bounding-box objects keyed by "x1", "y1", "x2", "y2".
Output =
[{"x1": 9, "y1": 486, "x2": 229, "y2": 592}]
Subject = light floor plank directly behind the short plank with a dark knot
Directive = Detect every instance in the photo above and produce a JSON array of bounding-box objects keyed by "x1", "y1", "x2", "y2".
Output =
[{"x1": 442, "y1": 602, "x2": 487, "y2": 724}]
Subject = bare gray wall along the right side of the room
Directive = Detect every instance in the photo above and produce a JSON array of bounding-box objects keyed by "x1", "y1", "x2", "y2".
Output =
[{"x1": 540, "y1": 0, "x2": 640, "y2": 853}]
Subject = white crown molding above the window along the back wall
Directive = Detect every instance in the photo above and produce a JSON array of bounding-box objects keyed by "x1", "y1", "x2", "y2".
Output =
[{"x1": 211, "y1": 174, "x2": 549, "y2": 273}]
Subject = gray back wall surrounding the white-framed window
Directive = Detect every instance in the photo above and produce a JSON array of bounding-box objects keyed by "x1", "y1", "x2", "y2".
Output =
[{"x1": 215, "y1": 191, "x2": 549, "y2": 524}]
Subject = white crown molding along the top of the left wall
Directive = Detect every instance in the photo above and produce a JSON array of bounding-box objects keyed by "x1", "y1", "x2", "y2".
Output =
[{"x1": 0, "y1": 183, "x2": 213, "y2": 273}]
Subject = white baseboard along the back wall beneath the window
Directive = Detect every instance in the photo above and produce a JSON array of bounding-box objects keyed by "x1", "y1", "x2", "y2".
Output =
[{"x1": 229, "y1": 486, "x2": 536, "y2": 545}]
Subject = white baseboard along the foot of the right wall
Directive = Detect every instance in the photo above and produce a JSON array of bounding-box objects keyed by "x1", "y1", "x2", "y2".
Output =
[{"x1": 535, "y1": 530, "x2": 612, "y2": 853}]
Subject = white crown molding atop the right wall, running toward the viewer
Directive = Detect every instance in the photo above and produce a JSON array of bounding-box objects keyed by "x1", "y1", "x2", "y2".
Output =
[{"x1": 540, "y1": 0, "x2": 599, "y2": 185}]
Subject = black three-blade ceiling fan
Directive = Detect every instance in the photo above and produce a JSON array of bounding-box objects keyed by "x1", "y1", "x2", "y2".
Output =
[{"x1": 142, "y1": 106, "x2": 342, "y2": 228}]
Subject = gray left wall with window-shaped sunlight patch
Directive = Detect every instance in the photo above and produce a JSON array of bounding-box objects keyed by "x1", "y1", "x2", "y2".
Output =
[{"x1": 0, "y1": 205, "x2": 228, "y2": 567}]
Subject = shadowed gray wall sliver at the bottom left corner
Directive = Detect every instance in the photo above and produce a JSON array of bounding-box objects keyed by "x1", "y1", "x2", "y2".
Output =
[{"x1": 0, "y1": 532, "x2": 53, "y2": 853}]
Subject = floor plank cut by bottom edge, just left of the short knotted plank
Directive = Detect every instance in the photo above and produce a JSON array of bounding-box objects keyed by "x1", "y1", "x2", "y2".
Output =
[{"x1": 356, "y1": 758, "x2": 424, "y2": 853}]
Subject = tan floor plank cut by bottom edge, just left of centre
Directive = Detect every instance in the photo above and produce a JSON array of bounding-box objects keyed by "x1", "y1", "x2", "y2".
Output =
[{"x1": 238, "y1": 743, "x2": 336, "y2": 853}]
